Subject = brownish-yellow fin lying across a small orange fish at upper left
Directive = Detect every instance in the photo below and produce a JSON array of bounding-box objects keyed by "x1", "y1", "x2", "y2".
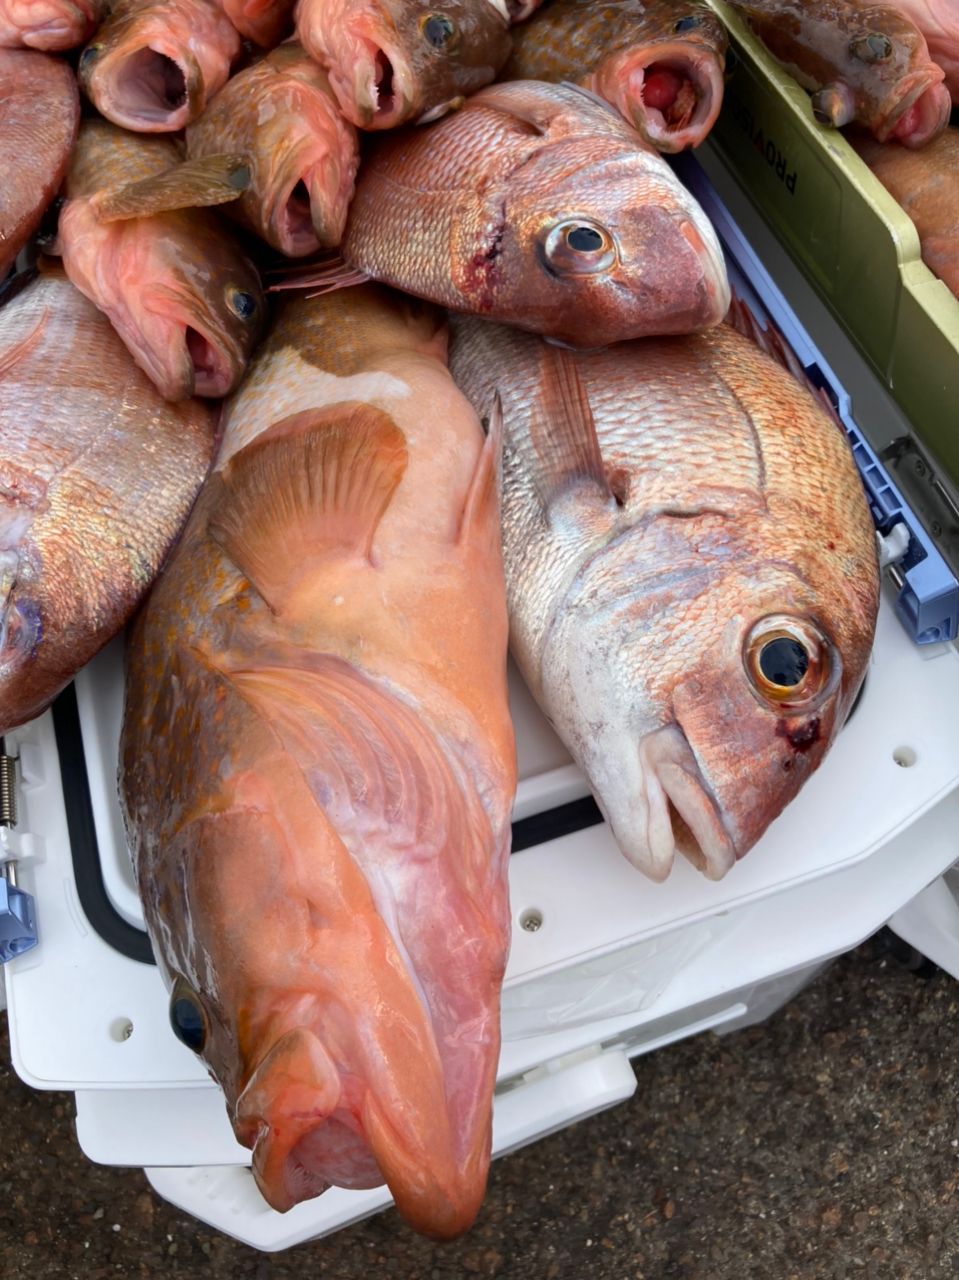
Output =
[{"x1": 91, "y1": 155, "x2": 251, "y2": 223}]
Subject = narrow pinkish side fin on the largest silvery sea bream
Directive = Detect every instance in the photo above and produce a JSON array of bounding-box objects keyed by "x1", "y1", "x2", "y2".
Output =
[{"x1": 530, "y1": 342, "x2": 613, "y2": 509}]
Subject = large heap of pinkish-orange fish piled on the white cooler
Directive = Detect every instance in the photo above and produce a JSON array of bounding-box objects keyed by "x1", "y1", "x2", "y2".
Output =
[{"x1": 0, "y1": 0, "x2": 880, "y2": 1236}]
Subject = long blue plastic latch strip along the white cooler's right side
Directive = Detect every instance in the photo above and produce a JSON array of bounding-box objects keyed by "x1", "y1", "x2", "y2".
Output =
[{"x1": 672, "y1": 155, "x2": 959, "y2": 644}]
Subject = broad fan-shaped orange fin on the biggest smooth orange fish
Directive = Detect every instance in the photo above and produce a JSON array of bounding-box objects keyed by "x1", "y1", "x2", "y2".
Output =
[{"x1": 210, "y1": 404, "x2": 407, "y2": 613}]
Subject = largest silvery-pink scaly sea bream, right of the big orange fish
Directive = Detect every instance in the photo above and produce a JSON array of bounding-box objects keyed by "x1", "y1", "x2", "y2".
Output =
[{"x1": 451, "y1": 319, "x2": 878, "y2": 879}]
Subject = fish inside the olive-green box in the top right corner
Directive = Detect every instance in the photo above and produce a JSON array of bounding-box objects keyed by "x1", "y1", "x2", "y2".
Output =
[{"x1": 730, "y1": 0, "x2": 959, "y2": 297}]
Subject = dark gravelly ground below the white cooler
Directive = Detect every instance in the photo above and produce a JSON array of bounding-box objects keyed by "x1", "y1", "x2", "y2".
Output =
[{"x1": 0, "y1": 940, "x2": 959, "y2": 1280}]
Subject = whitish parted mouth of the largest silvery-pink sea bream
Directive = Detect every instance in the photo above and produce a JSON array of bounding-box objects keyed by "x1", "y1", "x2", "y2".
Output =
[{"x1": 611, "y1": 724, "x2": 736, "y2": 881}]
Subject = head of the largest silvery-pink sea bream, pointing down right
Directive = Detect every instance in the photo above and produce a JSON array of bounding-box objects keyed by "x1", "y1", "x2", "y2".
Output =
[{"x1": 542, "y1": 520, "x2": 877, "y2": 881}]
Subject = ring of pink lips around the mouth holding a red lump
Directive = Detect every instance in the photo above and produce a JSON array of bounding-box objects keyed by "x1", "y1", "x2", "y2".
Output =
[{"x1": 624, "y1": 41, "x2": 723, "y2": 154}]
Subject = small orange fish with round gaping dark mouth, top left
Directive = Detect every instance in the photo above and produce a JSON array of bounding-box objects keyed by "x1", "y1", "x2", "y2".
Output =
[{"x1": 79, "y1": 0, "x2": 241, "y2": 133}]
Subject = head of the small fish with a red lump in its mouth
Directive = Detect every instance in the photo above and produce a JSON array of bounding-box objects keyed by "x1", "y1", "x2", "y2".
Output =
[{"x1": 589, "y1": 4, "x2": 727, "y2": 152}]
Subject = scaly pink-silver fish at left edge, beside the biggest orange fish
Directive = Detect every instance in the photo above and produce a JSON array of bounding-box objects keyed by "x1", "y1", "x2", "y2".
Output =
[{"x1": 0, "y1": 268, "x2": 214, "y2": 733}]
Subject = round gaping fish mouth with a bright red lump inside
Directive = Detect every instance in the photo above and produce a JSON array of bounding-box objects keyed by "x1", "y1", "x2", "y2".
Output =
[{"x1": 626, "y1": 44, "x2": 723, "y2": 152}]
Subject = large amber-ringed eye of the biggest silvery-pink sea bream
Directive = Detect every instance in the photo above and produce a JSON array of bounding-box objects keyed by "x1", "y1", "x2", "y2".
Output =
[{"x1": 744, "y1": 616, "x2": 832, "y2": 709}]
